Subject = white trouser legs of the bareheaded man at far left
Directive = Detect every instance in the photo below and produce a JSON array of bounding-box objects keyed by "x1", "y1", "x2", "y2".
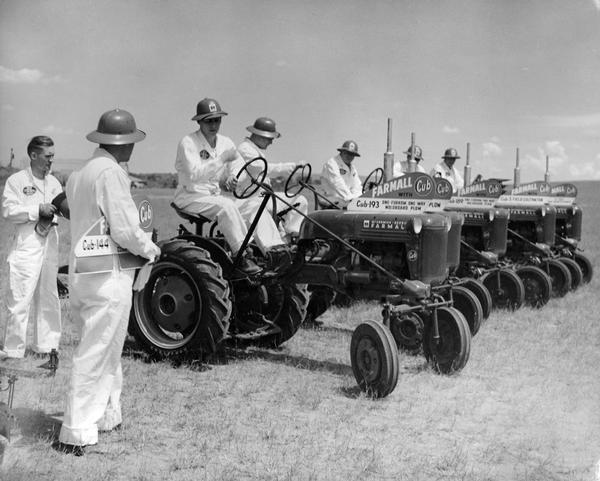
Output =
[{"x1": 4, "y1": 223, "x2": 60, "y2": 357}]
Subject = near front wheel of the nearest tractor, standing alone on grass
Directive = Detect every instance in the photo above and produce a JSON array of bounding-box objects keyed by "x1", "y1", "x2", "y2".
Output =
[{"x1": 350, "y1": 320, "x2": 400, "y2": 398}]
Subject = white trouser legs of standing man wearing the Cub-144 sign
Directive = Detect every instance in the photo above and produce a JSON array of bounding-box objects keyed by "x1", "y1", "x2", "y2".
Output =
[{"x1": 59, "y1": 270, "x2": 134, "y2": 446}]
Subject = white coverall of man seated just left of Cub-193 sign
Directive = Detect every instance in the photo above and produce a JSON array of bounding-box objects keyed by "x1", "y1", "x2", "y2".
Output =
[{"x1": 320, "y1": 154, "x2": 362, "y2": 208}]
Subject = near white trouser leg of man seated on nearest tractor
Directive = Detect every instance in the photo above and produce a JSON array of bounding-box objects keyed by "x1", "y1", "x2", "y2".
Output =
[{"x1": 181, "y1": 195, "x2": 248, "y2": 255}]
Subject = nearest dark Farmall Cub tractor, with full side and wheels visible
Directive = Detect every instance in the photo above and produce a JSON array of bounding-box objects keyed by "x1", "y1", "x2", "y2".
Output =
[{"x1": 130, "y1": 158, "x2": 471, "y2": 397}]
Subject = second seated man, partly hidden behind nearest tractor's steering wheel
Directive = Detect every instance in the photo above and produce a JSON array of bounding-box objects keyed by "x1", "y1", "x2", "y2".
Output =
[{"x1": 236, "y1": 117, "x2": 308, "y2": 239}]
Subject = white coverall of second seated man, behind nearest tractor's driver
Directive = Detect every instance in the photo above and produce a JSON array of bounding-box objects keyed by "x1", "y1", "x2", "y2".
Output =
[{"x1": 238, "y1": 138, "x2": 308, "y2": 235}]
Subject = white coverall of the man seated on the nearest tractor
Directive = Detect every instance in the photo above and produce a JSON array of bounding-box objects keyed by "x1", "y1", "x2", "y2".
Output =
[{"x1": 173, "y1": 130, "x2": 283, "y2": 255}]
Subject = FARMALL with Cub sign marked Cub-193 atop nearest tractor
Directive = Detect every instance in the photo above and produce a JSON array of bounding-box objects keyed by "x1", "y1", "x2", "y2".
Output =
[{"x1": 348, "y1": 172, "x2": 452, "y2": 213}]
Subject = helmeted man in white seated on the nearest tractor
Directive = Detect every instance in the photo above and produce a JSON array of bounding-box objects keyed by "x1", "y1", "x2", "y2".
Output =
[{"x1": 173, "y1": 98, "x2": 283, "y2": 274}]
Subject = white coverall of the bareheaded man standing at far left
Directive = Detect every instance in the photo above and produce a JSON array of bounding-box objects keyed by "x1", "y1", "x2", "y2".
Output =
[{"x1": 2, "y1": 167, "x2": 62, "y2": 358}]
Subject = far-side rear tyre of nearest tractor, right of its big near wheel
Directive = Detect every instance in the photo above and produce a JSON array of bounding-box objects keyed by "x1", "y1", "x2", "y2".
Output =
[{"x1": 234, "y1": 284, "x2": 308, "y2": 347}]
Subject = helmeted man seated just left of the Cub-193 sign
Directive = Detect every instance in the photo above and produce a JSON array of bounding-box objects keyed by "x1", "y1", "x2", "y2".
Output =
[{"x1": 320, "y1": 140, "x2": 362, "y2": 207}]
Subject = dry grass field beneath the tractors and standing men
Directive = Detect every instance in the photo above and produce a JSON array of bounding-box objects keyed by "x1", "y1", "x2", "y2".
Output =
[{"x1": 0, "y1": 182, "x2": 600, "y2": 481}]
